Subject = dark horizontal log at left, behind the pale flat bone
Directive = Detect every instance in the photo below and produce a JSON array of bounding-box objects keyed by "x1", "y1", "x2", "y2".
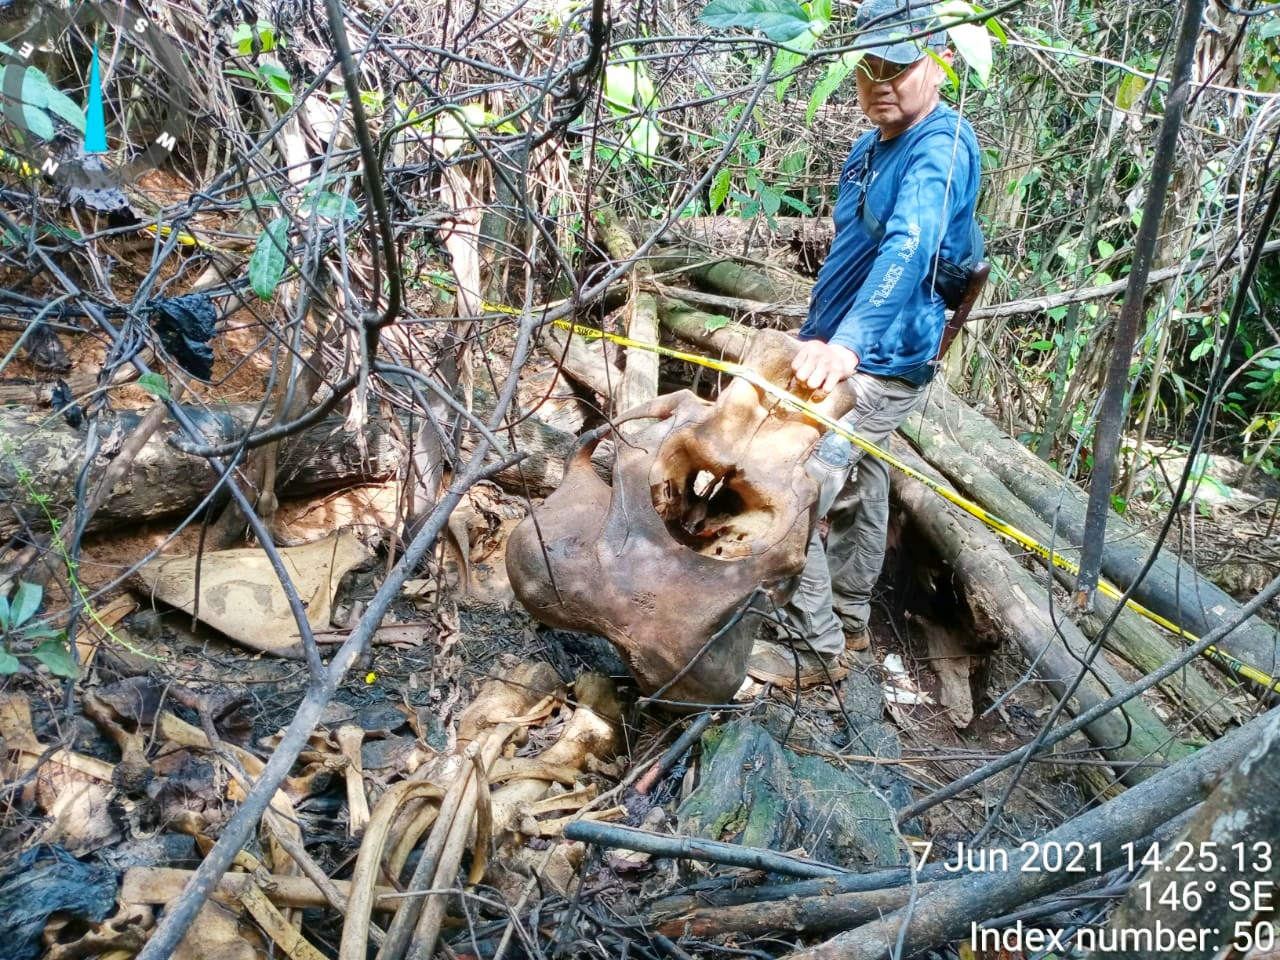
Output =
[{"x1": 0, "y1": 390, "x2": 573, "y2": 538}]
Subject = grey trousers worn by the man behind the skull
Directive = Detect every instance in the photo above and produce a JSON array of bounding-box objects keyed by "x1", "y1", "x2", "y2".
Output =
[{"x1": 782, "y1": 374, "x2": 924, "y2": 657}]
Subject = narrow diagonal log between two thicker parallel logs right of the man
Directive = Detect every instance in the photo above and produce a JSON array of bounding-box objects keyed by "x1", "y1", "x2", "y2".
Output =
[{"x1": 902, "y1": 412, "x2": 1238, "y2": 736}]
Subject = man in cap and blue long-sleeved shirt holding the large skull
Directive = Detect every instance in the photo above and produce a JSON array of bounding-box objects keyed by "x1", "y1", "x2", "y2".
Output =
[{"x1": 749, "y1": 0, "x2": 982, "y2": 686}]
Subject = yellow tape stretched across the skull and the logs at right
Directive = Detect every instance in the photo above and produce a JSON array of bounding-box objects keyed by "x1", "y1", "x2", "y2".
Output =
[{"x1": 552, "y1": 320, "x2": 1280, "y2": 692}]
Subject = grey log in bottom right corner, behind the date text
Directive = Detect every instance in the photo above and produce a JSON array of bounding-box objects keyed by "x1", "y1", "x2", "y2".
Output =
[{"x1": 786, "y1": 710, "x2": 1275, "y2": 960}]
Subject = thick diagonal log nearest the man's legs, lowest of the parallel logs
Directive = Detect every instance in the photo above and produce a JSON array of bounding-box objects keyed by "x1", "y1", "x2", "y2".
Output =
[{"x1": 890, "y1": 440, "x2": 1189, "y2": 785}]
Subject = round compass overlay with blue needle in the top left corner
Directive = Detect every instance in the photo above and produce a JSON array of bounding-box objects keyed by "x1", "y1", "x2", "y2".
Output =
[{"x1": 0, "y1": 0, "x2": 192, "y2": 189}]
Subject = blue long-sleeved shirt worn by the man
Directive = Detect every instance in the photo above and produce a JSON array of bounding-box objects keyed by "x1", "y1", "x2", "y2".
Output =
[{"x1": 800, "y1": 104, "x2": 980, "y2": 376}]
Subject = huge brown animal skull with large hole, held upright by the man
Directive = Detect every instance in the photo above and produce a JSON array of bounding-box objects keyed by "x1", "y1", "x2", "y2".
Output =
[{"x1": 507, "y1": 330, "x2": 852, "y2": 703}]
